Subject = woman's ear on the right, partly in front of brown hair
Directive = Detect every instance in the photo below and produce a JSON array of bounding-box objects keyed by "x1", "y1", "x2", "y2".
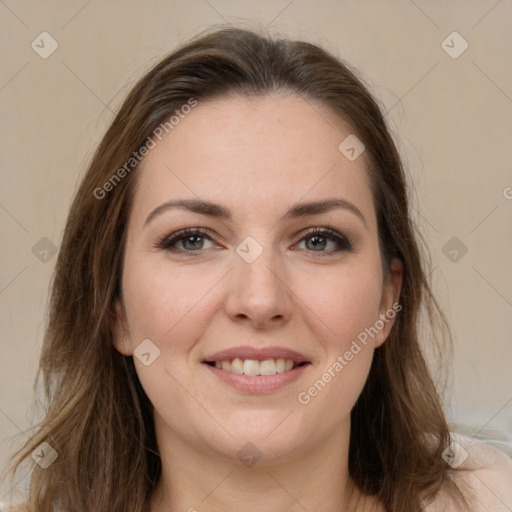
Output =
[{"x1": 375, "y1": 258, "x2": 403, "y2": 347}]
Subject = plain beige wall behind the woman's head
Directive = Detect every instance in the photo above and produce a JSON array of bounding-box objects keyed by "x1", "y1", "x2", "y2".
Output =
[{"x1": 0, "y1": 0, "x2": 512, "y2": 501}]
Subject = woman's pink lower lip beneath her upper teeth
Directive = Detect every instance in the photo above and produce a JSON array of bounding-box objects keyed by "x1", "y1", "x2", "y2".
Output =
[{"x1": 203, "y1": 363, "x2": 311, "y2": 393}]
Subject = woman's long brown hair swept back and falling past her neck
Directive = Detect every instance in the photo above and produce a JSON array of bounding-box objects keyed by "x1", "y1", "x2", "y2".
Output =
[{"x1": 5, "y1": 28, "x2": 468, "y2": 512}]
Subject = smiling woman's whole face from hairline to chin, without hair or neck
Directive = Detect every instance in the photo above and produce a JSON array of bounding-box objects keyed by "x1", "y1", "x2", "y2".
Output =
[{"x1": 115, "y1": 94, "x2": 401, "y2": 461}]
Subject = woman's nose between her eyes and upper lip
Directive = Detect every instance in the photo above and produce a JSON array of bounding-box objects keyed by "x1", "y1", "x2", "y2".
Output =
[{"x1": 225, "y1": 239, "x2": 294, "y2": 329}]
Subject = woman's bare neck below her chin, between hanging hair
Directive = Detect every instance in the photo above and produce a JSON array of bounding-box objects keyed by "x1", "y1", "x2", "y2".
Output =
[{"x1": 150, "y1": 413, "x2": 368, "y2": 512}]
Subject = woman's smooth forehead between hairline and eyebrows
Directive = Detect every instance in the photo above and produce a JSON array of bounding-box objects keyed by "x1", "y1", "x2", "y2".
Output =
[{"x1": 134, "y1": 93, "x2": 373, "y2": 228}]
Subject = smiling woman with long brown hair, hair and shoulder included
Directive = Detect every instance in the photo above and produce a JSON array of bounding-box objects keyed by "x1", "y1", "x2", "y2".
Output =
[{"x1": 5, "y1": 28, "x2": 512, "y2": 512}]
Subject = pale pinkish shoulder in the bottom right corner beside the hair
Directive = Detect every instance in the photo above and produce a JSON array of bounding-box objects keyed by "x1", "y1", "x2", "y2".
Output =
[{"x1": 426, "y1": 434, "x2": 512, "y2": 512}]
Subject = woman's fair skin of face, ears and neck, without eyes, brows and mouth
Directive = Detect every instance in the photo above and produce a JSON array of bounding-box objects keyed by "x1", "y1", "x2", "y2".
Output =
[{"x1": 115, "y1": 93, "x2": 402, "y2": 512}]
